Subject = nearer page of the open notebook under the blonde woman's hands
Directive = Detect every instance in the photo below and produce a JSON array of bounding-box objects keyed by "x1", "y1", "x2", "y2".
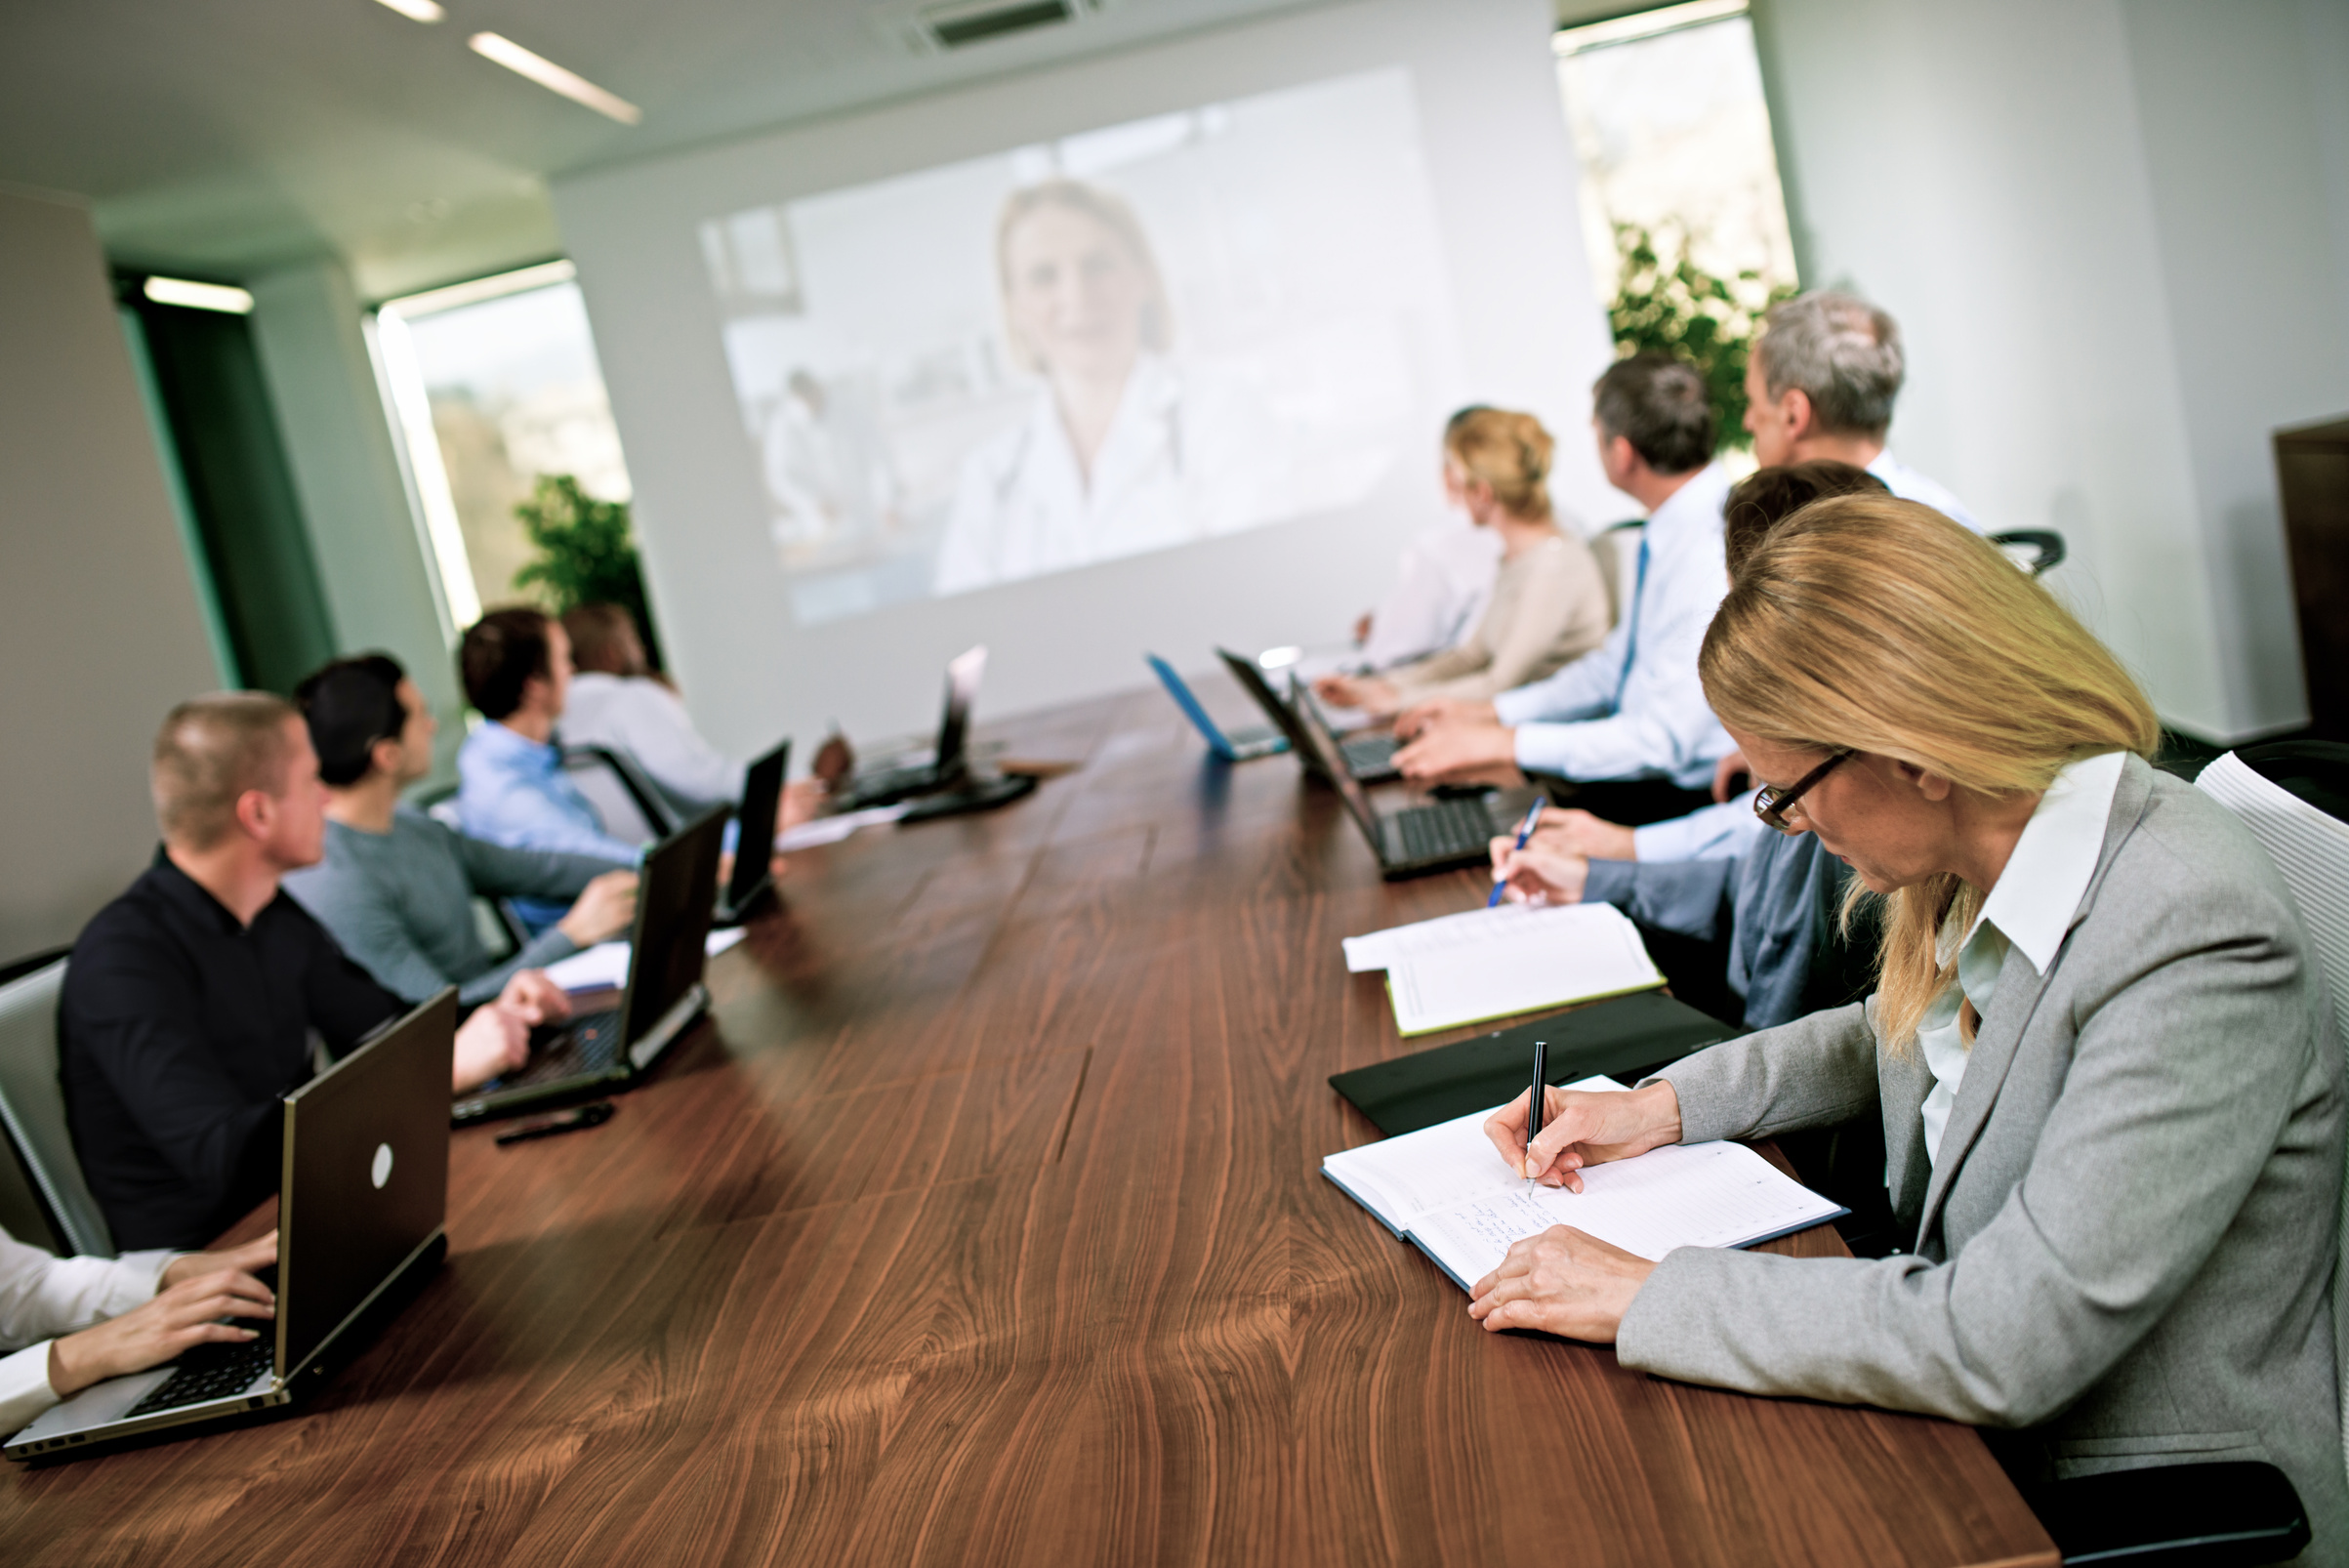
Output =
[{"x1": 1410, "y1": 1142, "x2": 1844, "y2": 1291}]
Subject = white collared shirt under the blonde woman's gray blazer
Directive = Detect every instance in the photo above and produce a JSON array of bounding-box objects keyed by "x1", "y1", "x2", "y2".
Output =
[{"x1": 1916, "y1": 752, "x2": 2128, "y2": 1166}]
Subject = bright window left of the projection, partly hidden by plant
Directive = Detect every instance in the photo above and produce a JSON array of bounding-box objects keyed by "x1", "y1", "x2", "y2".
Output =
[{"x1": 376, "y1": 261, "x2": 630, "y2": 628}]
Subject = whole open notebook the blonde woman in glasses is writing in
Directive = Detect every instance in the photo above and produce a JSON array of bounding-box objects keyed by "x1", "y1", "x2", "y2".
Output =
[{"x1": 1323, "y1": 1079, "x2": 1851, "y2": 1291}]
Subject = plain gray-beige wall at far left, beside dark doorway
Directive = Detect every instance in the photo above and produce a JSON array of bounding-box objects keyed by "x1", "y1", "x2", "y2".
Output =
[{"x1": 0, "y1": 190, "x2": 214, "y2": 957}]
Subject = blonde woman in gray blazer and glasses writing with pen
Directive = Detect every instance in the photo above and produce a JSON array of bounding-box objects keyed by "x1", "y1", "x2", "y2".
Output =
[{"x1": 1470, "y1": 496, "x2": 2349, "y2": 1563}]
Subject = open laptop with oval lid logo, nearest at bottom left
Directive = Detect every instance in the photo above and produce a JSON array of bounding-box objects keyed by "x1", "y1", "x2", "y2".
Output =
[{"x1": 5, "y1": 987, "x2": 456, "y2": 1460}]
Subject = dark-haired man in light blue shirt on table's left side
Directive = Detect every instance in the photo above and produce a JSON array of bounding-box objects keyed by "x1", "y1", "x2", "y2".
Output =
[{"x1": 456, "y1": 609, "x2": 639, "y2": 935}]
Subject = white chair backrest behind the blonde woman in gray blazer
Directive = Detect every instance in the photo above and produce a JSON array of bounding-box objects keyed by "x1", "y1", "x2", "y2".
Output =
[{"x1": 2197, "y1": 743, "x2": 2349, "y2": 1495}]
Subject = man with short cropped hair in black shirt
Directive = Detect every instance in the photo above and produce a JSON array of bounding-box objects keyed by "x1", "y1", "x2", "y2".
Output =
[{"x1": 59, "y1": 691, "x2": 566, "y2": 1251}]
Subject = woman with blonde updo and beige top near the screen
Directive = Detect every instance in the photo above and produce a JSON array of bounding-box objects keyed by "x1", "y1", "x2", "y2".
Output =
[{"x1": 1313, "y1": 409, "x2": 1609, "y2": 715}]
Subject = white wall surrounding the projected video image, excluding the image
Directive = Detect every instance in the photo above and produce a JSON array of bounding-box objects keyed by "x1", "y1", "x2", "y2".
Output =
[{"x1": 555, "y1": 0, "x2": 1632, "y2": 752}]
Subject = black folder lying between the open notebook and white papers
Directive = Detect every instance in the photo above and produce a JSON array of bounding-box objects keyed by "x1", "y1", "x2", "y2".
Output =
[{"x1": 1330, "y1": 992, "x2": 1746, "y2": 1137}]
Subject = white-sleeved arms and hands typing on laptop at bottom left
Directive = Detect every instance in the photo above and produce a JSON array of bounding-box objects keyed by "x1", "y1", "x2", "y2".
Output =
[{"x1": 0, "y1": 1229, "x2": 277, "y2": 1436}]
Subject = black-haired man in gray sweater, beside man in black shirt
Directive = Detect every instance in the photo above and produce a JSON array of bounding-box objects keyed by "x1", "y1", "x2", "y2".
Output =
[{"x1": 284, "y1": 653, "x2": 637, "y2": 1007}]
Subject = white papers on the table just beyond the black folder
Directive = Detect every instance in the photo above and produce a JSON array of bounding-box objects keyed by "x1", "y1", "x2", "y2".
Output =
[{"x1": 1346, "y1": 903, "x2": 1663, "y2": 1034}]
